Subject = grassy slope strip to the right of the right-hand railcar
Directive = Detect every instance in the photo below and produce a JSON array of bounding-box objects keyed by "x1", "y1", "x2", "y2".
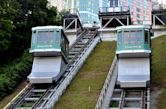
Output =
[{"x1": 152, "y1": 35, "x2": 166, "y2": 109}]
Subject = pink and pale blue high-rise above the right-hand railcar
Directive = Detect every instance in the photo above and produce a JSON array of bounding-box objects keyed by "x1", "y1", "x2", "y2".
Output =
[{"x1": 120, "y1": 0, "x2": 152, "y2": 24}]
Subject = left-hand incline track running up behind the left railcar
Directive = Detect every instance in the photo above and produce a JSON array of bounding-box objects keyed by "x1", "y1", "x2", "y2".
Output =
[{"x1": 4, "y1": 29, "x2": 100, "y2": 109}]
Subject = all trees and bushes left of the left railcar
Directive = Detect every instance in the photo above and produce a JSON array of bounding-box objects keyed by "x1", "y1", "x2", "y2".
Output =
[{"x1": 0, "y1": 0, "x2": 61, "y2": 100}]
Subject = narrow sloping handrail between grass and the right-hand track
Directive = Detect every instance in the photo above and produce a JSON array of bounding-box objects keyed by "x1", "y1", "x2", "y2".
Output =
[{"x1": 95, "y1": 56, "x2": 117, "y2": 109}]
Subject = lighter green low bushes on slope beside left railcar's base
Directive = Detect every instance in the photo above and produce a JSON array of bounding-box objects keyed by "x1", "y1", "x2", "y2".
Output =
[{"x1": 0, "y1": 51, "x2": 32, "y2": 100}]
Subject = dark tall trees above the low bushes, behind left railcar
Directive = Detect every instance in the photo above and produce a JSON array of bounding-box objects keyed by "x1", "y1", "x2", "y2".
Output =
[{"x1": 0, "y1": 0, "x2": 61, "y2": 64}]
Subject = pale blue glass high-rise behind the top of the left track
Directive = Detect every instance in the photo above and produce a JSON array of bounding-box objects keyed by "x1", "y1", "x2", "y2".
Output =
[{"x1": 65, "y1": 0, "x2": 109, "y2": 25}]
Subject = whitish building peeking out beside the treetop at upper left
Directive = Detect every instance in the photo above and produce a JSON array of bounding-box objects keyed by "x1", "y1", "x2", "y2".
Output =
[{"x1": 48, "y1": 0, "x2": 65, "y2": 11}]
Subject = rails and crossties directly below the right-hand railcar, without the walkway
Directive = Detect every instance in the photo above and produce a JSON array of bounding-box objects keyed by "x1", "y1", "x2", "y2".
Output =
[{"x1": 109, "y1": 88, "x2": 150, "y2": 109}]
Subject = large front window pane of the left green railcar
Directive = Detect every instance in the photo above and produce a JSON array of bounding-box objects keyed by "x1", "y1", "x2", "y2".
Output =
[{"x1": 36, "y1": 31, "x2": 55, "y2": 45}]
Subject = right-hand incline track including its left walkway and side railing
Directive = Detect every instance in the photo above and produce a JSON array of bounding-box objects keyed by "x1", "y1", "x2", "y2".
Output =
[{"x1": 95, "y1": 57, "x2": 150, "y2": 109}]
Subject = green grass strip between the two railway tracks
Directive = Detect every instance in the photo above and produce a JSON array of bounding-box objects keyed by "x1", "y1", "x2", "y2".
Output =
[{"x1": 54, "y1": 42, "x2": 116, "y2": 109}]
